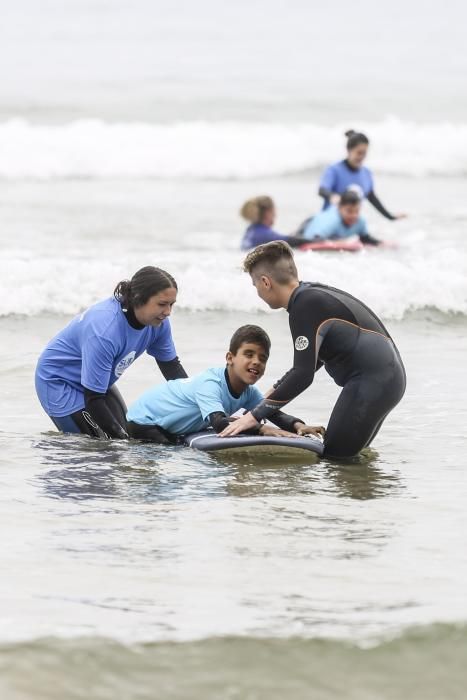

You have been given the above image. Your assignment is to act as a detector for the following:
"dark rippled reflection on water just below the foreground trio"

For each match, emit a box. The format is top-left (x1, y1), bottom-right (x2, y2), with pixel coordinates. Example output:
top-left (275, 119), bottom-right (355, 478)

top-left (33, 433), bottom-right (401, 503)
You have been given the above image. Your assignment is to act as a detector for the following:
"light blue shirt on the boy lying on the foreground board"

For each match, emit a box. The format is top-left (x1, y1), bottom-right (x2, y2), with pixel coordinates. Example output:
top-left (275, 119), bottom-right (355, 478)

top-left (127, 367), bottom-right (263, 435)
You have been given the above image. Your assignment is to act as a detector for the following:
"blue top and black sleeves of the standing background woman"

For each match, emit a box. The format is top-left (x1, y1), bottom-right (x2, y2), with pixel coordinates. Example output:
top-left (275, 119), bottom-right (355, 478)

top-left (318, 160), bottom-right (396, 221)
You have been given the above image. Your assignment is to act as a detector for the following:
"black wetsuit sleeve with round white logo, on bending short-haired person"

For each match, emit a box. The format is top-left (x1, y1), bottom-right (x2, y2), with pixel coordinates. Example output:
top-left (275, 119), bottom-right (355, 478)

top-left (252, 294), bottom-right (332, 420)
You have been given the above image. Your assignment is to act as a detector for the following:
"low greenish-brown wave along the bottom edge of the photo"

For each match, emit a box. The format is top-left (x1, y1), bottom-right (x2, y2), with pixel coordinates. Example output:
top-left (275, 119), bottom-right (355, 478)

top-left (0, 625), bottom-right (467, 700)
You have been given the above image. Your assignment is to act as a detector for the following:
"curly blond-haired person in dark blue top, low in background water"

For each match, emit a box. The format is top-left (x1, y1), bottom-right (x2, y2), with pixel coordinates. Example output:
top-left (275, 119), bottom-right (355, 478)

top-left (240, 196), bottom-right (303, 250)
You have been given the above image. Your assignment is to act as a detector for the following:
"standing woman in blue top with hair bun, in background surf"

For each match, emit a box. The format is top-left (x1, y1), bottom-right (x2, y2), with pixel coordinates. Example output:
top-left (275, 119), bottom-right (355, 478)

top-left (318, 129), bottom-right (407, 221)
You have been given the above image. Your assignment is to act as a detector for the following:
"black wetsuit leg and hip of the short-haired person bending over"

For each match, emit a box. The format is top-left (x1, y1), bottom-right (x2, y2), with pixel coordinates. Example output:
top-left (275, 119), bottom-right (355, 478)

top-left (324, 333), bottom-right (406, 459)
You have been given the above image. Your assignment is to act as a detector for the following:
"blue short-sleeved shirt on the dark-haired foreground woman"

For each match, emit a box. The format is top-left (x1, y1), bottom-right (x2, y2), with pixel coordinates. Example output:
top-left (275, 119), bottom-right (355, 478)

top-left (36, 297), bottom-right (176, 418)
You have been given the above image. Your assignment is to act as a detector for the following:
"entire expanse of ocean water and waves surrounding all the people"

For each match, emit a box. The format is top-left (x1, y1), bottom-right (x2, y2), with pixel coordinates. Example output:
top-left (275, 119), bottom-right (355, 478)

top-left (0, 0), bottom-right (467, 700)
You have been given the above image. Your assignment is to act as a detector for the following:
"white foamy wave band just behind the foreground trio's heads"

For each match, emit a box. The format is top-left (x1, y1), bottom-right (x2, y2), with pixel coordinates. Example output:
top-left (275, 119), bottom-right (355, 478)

top-left (0, 247), bottom-right (467, 319)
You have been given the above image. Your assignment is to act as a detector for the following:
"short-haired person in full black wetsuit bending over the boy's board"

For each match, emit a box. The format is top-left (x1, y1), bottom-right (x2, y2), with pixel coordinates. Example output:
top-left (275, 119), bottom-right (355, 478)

top-left (221, 241), bottom-right (406, 459)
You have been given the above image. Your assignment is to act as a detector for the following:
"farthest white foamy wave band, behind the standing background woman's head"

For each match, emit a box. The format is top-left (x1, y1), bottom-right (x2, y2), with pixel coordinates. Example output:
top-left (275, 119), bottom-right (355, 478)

top-left (0, 118), bottom-right (467, 179)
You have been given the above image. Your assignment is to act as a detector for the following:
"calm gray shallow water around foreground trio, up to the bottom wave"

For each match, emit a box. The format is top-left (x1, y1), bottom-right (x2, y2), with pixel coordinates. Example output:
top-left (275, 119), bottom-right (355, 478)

top-left (0, 313), bottom-right (467, 641)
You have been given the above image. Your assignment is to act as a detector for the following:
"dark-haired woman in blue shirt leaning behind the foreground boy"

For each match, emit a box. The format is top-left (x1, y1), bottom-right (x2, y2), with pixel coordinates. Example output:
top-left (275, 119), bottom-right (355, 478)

top-left (36, 266), bottom-right (187, 439)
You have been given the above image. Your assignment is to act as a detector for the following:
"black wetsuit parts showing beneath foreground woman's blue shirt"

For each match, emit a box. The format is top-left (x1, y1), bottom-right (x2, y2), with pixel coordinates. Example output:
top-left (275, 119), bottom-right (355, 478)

top-left (57, 309), bottom-right (188, 439)
